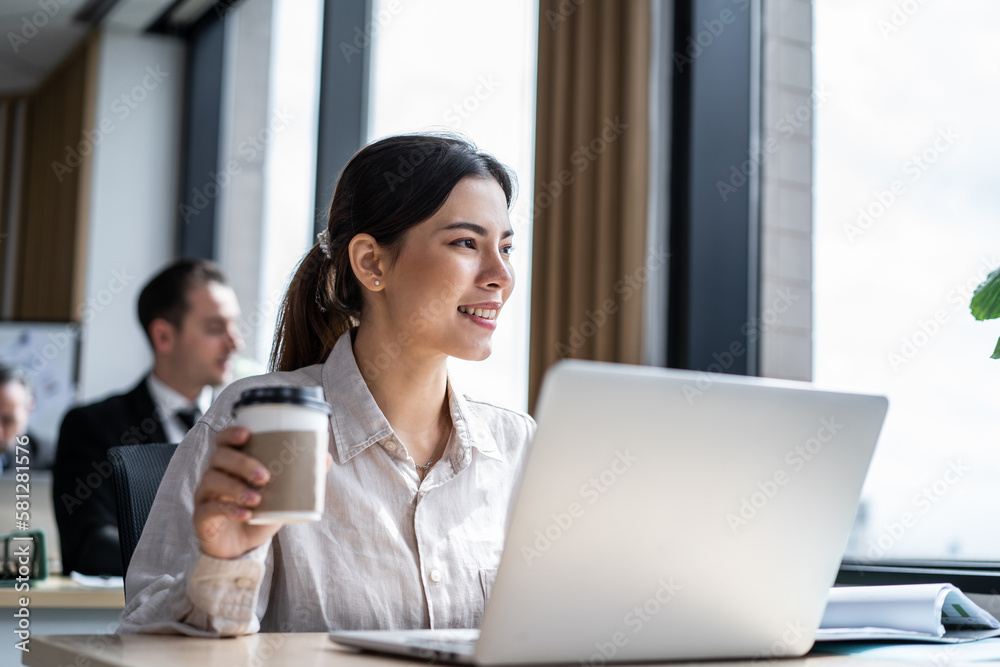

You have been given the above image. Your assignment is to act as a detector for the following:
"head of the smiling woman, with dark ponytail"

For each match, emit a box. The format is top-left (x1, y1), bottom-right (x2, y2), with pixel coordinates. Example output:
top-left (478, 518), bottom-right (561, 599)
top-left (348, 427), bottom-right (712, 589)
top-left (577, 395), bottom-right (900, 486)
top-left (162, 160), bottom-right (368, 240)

top-left (271, 134), bottom-right (514, 370)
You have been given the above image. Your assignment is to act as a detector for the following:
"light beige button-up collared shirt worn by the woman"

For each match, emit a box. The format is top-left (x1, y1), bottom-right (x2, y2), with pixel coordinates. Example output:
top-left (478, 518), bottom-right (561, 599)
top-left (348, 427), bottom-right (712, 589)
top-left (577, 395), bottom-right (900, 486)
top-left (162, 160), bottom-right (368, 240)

top-left (121, 333), bottom-right (535, 636)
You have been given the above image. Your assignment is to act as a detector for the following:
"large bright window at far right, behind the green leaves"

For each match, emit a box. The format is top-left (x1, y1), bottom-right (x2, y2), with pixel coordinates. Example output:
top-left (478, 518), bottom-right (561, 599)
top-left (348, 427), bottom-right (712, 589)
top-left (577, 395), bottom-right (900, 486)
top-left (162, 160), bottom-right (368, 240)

top-left (814, 0), bottom-right (1000, 561)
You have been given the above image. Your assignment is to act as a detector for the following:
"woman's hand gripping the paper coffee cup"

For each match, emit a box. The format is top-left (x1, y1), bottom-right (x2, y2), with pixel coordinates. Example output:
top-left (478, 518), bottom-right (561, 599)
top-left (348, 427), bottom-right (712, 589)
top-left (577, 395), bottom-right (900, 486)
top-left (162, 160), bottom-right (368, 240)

top-left (194, 426), bottom-right (282, 558)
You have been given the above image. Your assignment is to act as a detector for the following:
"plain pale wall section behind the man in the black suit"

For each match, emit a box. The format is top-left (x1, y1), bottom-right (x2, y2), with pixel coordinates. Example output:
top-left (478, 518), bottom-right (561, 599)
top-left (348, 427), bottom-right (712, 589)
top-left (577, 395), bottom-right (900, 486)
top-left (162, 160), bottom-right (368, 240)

top-left (78, 29), bottom-right (184, 401)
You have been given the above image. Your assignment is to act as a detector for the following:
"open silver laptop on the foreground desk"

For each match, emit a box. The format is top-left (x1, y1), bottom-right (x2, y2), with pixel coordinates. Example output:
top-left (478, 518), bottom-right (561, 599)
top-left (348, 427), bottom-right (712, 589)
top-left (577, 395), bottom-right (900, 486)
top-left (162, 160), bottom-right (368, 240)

top-left (330, 360), bottom-right (888, 665)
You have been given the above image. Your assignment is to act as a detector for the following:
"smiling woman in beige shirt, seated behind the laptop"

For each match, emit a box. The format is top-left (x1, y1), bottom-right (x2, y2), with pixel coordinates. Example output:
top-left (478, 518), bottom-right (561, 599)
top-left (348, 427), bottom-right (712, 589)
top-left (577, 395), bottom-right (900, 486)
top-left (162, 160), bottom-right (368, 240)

top-left (121, 135), bottom-right (535, 635)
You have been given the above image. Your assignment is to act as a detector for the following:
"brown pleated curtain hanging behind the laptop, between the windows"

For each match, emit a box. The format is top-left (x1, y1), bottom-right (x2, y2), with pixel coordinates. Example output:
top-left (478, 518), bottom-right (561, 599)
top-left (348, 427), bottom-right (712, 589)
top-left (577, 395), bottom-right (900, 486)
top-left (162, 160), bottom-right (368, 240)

top-left (529, 0), bottom-right (662, 410)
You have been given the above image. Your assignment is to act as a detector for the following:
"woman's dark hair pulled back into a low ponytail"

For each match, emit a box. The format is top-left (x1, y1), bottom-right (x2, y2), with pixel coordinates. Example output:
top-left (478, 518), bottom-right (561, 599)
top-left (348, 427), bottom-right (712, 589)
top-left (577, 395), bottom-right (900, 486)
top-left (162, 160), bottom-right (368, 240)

top-left (270, 134), bottom-right (515, 371)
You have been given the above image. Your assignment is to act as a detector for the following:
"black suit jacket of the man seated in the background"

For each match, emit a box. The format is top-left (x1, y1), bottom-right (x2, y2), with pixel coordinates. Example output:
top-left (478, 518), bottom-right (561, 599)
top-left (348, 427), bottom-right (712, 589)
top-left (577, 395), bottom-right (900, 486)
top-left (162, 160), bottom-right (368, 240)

top-left (52, 378), bottom-right (167, 575)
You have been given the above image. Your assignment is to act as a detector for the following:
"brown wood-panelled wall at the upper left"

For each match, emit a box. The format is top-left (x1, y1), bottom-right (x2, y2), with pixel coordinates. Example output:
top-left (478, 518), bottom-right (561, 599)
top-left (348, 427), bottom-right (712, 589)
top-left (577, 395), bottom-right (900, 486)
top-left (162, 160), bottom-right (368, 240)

top-left (0, 33), bottom-right (99, 321)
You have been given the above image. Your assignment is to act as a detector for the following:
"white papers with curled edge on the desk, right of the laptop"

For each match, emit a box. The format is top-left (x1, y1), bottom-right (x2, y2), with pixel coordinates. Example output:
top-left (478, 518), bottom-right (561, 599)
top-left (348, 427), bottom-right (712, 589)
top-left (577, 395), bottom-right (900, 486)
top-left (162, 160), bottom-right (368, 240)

top-left (816, 584), bottom-right (1000, 643)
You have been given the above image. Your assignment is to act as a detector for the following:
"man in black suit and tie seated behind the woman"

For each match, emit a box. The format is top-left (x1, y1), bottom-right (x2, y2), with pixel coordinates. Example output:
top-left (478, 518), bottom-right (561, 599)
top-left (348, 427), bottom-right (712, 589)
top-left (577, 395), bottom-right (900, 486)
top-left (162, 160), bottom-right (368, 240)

top-left (52, 259), bottom-right (242, 575)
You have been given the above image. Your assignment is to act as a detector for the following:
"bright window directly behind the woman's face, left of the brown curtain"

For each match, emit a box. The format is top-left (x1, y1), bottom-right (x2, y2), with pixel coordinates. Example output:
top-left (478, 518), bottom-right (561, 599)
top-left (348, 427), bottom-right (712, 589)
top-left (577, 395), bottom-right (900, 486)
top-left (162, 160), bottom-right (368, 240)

top-left (368, 0), bottom-right (538, 410)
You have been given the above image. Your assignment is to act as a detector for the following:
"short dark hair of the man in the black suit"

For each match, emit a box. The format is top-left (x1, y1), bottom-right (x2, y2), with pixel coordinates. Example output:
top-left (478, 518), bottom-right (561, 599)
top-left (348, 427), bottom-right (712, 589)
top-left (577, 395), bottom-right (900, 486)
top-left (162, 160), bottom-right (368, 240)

top-left (139, 259), bottom-right (228, 345)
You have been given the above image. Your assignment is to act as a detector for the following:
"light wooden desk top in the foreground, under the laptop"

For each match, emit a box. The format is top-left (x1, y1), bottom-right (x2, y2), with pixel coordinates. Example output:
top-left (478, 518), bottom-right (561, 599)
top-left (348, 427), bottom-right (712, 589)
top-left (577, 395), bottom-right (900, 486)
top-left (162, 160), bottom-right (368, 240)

top-left (22, 632), bottom-right (880, 667)
